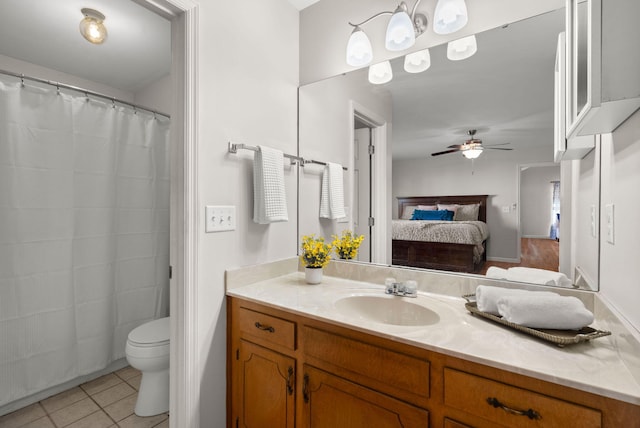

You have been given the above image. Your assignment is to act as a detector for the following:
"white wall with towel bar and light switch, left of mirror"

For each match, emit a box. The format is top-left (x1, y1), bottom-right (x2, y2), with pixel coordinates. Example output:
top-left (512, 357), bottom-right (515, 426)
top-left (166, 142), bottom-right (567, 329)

top-left (196, 0), bottom-right (299, 428)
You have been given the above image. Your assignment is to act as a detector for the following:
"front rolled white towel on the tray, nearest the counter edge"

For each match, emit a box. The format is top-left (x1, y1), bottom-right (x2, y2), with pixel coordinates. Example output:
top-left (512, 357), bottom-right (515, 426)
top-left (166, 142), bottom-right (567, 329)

top-left (498, 296), bottom-right (593, 330)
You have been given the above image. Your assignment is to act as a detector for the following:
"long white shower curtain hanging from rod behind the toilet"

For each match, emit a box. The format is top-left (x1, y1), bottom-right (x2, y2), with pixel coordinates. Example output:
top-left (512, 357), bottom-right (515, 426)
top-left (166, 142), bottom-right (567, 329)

top-left (0, 76), bottom-right (169, 406)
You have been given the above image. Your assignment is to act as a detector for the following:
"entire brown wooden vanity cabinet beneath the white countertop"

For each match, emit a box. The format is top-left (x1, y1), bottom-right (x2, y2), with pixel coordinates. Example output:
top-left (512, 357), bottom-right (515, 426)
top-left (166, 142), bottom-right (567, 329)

top-left (227, 297), bottom-right (640, 428)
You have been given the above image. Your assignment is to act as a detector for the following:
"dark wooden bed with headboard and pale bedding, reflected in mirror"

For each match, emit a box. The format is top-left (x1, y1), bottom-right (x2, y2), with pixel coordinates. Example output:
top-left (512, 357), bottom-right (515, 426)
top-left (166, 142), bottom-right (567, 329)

top-left (391, 195), bottom-right (489, 273)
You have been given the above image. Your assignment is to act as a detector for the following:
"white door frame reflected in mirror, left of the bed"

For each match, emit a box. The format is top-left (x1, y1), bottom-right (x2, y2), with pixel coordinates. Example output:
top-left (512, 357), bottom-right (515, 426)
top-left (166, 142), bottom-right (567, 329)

top-left (349, 100), bottom-right (391, 264)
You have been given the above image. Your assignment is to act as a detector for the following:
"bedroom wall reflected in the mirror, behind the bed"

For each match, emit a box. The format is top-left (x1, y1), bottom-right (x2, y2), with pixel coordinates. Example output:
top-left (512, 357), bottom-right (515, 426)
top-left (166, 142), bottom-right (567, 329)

top-left (393, 147), bottom-right (553, 261)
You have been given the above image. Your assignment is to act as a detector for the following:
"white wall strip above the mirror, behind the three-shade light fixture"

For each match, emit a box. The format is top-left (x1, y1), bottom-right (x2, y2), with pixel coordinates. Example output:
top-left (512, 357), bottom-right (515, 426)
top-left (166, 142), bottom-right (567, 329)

top-left (300, 0), bottom-right (565, 84)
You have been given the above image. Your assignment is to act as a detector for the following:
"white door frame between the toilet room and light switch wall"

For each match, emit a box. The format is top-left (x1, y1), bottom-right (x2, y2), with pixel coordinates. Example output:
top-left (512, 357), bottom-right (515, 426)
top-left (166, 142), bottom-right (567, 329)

top-left (139, 0), bottom-right (202, 428)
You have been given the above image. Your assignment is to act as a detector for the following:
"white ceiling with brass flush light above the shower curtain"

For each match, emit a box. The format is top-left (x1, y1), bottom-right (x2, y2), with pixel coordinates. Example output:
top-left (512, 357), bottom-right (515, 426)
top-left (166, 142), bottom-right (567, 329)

top-left (0, 0), bottom-right (171, 92)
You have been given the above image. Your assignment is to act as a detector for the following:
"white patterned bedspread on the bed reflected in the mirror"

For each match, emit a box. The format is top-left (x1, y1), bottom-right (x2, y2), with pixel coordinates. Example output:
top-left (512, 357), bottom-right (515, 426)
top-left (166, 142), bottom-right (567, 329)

top-left (391, 220), bottom-right (489, 262)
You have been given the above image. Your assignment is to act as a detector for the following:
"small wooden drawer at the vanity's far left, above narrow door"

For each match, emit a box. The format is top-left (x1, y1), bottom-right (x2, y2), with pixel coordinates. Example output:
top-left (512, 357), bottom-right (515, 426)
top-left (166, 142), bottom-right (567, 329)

top-left (238, 308), bottom-right (296, 350)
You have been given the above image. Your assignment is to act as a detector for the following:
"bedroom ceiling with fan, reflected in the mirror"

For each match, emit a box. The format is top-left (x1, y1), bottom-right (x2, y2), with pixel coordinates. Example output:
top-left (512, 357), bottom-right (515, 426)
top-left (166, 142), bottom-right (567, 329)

top-left (384, 9), bottom-right (564, 159)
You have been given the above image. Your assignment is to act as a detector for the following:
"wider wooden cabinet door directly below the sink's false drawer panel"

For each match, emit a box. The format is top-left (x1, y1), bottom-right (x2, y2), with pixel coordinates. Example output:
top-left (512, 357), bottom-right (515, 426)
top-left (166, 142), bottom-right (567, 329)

top-left (302, 366), bottom-right (429, 428)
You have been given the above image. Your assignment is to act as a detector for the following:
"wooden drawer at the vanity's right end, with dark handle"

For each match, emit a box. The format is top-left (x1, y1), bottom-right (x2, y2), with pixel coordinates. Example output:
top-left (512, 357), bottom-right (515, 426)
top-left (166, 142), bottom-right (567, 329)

top-left (444, 368), bottom-right (602, 428)
